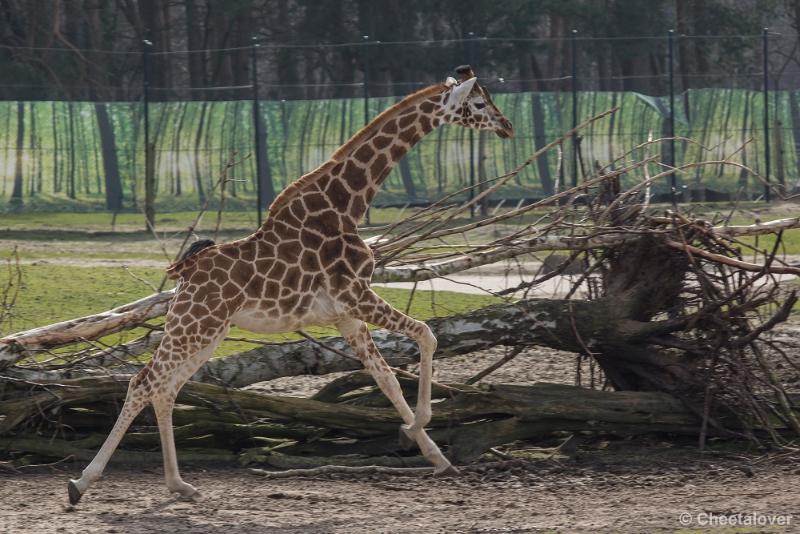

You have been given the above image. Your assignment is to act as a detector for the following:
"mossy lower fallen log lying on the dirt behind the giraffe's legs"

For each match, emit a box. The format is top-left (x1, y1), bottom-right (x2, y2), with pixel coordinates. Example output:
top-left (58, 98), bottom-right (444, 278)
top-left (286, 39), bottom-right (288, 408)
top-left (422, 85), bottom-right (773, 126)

top-left (0, 377), bottom-right (716, 468)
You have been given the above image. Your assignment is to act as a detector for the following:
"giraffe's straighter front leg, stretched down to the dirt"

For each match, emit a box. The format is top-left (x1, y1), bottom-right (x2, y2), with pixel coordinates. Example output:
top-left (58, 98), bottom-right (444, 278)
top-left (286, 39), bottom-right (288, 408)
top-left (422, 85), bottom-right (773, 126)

top-left (337, 319), bottom-right (458, 475)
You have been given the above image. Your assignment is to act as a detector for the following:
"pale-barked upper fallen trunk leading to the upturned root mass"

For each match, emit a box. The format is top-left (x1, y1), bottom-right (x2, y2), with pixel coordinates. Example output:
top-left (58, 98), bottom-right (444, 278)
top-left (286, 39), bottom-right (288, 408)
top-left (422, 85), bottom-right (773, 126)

top-left (6, 299), bottom-right (632, 387)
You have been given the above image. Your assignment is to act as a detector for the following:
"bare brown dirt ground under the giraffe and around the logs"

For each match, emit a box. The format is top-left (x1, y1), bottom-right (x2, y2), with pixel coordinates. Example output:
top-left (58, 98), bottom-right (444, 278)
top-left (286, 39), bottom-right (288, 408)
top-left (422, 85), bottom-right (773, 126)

top-left (0, 336), bottom-right (800, 534)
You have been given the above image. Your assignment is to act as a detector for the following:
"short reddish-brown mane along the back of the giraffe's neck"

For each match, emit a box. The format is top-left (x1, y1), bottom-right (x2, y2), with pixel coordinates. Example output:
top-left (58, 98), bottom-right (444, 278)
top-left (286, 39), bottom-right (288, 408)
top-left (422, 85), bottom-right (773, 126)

top-left (269, 83), bottom-right (448, 214)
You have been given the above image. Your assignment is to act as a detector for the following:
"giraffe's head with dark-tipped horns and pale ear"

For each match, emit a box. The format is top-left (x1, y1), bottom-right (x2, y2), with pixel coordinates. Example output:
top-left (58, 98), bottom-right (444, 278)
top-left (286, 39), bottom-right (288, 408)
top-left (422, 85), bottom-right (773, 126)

top-left (442, 65), bottom-right (514, 139)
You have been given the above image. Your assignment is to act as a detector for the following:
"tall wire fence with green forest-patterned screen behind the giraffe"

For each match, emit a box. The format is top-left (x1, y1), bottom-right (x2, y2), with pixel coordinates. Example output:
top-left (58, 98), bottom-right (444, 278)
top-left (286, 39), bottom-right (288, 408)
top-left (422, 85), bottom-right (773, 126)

top-left (0, 31), bottom-right (800, 215)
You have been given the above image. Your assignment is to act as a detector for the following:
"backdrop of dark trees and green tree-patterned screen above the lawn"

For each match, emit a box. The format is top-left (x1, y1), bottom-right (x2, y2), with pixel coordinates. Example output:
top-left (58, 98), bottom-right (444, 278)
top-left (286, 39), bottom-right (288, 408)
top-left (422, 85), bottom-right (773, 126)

top-left (0, 0), bottom-right (800, 211)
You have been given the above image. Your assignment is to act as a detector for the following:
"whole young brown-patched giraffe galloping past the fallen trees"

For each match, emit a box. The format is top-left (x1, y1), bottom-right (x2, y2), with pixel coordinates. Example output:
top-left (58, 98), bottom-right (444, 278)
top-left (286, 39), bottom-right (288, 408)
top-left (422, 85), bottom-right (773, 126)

top-left (68, 66), bottom-right (514, 505)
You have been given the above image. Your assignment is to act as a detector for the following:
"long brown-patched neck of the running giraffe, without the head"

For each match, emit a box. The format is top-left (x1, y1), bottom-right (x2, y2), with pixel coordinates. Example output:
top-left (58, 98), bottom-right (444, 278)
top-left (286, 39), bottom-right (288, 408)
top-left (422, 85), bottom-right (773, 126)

top-left (270, 86), bottom-right (443, 224)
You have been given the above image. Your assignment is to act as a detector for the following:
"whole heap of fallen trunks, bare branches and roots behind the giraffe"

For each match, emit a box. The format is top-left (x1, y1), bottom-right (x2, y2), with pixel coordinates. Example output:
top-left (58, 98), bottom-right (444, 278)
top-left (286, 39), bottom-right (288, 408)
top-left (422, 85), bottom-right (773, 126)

top-left (0, 110), bottom-right (800, 468)
